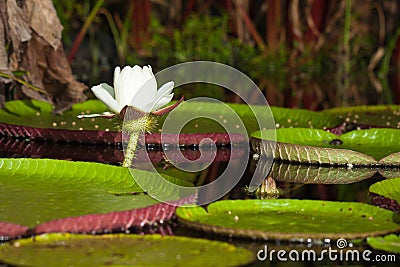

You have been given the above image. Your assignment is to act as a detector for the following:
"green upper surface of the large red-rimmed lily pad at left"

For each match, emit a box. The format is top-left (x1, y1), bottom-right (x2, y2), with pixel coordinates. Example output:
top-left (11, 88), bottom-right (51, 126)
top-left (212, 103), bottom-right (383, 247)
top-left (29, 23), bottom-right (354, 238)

top-left (0, 159), bottom-right (192, 227)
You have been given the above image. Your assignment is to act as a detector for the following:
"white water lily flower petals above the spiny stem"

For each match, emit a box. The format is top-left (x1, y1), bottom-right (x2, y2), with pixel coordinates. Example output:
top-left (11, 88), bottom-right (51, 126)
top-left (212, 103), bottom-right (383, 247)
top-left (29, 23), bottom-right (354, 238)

top-left (91, 65), bottom-right (174, 113)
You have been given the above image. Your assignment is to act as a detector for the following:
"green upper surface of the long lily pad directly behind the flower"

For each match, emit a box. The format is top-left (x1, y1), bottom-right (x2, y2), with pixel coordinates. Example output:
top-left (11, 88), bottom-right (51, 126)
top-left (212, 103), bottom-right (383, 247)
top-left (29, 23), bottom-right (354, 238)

top-left (0, 100), bottom-right (342, 133)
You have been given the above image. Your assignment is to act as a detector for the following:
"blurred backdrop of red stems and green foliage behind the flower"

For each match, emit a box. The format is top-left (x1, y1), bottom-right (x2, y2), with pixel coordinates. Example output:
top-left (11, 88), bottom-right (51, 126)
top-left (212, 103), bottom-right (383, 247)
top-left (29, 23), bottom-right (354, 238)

top-left (54, 0), bottom-right (400, 109)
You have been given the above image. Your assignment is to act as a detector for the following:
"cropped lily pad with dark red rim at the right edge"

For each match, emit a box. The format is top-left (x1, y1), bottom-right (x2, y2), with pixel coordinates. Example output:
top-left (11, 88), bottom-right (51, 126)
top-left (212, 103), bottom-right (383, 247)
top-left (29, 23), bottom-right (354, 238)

top-left (369, 178), bottom-right (400, 212)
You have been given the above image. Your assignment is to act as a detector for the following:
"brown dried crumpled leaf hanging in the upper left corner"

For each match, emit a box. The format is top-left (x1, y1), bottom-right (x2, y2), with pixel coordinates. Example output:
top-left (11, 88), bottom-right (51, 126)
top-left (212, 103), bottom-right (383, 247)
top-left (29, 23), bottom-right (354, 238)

top-left (0, 0), bottom-right (87, 113)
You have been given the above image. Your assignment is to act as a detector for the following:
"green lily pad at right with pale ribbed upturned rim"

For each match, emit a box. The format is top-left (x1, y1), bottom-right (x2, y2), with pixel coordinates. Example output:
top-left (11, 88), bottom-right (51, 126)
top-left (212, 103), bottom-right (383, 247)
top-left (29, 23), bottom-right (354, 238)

top-left (251, 128), bottom-right (400, 165)
